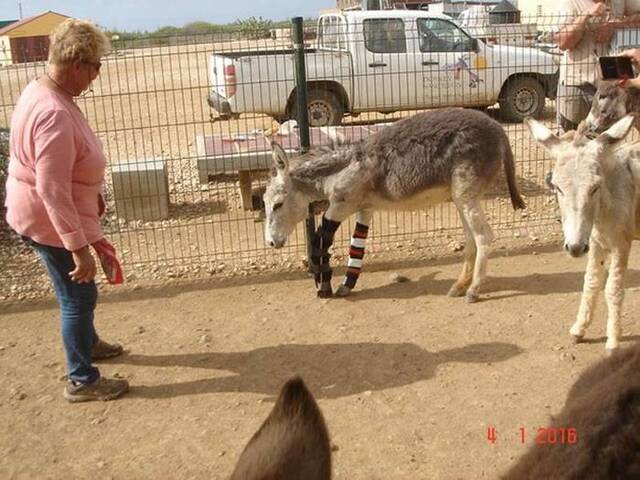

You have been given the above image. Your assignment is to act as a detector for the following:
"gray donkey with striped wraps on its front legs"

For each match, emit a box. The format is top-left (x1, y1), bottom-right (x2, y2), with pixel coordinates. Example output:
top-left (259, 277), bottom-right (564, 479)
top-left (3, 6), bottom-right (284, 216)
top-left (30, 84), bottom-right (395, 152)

top-left (264, 109), bottom-right (525, 302)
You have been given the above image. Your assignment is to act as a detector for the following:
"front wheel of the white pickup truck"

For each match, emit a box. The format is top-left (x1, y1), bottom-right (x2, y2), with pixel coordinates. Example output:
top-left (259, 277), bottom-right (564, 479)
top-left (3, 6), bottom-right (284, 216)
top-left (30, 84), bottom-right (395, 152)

top-left (498, 77), bottom-right (545, 122)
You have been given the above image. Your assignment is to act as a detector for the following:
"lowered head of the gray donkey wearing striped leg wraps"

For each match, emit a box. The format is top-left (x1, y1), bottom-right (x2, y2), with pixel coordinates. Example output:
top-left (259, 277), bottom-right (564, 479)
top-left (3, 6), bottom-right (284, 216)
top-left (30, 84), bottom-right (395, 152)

top-left (264, 142), bottom-right (309, 248)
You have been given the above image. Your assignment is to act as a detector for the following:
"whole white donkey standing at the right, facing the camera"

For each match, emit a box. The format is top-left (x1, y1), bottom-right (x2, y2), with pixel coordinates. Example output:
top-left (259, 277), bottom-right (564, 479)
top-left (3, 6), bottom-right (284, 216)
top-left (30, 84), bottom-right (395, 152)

top-left (527, 115), bottom-right (640, 352)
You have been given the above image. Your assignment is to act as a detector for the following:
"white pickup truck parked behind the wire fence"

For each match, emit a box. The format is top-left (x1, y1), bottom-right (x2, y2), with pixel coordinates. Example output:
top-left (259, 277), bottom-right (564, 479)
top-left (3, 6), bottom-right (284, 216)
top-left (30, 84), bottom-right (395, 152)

top-left (207, 10), bottom-right (558, 126)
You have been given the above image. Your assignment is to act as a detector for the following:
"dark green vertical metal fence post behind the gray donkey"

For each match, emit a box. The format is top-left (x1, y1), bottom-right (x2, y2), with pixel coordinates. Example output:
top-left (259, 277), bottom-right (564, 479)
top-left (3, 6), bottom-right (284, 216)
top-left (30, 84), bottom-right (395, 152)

top-left (291, 17), bottom-right (316, 268)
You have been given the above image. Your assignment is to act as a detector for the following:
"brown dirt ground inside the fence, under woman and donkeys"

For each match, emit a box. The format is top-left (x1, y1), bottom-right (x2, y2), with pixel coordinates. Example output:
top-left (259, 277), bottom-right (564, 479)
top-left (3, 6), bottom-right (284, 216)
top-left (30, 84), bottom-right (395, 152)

top-left (0, 245), bottom-right (640, 480)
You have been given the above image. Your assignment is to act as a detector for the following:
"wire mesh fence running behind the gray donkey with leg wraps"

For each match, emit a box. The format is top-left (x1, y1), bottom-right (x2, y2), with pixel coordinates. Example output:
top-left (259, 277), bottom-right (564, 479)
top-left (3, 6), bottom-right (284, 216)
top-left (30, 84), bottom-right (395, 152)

top-left (0, 10), bottom-right (636, 294)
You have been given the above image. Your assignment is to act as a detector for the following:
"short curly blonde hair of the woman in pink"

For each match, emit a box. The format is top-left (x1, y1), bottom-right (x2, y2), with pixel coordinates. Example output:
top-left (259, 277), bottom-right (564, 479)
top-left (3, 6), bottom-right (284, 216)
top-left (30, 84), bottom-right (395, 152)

top-left (49, 18), bottom-right (110, 66)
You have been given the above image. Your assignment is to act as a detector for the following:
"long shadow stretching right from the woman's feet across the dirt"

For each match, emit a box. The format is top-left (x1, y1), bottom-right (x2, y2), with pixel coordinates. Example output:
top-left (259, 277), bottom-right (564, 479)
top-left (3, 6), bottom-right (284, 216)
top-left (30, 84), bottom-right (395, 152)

top-left (109, 342), bottom-right (522, 400)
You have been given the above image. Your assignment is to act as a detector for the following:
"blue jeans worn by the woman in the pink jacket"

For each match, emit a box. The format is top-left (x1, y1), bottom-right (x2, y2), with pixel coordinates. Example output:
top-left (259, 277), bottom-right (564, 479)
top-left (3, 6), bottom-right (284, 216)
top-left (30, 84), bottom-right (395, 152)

top-left (24, 238), bottom-right (100, 383)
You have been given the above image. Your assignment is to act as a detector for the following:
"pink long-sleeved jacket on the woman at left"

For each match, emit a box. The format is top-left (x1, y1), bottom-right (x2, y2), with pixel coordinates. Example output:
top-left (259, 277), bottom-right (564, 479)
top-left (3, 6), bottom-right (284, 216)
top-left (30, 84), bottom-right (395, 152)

top-left (5, 80), bottom-right (105, 251)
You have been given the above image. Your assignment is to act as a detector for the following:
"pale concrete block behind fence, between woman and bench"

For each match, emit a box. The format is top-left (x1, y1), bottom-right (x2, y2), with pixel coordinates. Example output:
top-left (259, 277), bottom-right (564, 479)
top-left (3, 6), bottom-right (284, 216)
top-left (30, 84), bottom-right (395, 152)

top-left (111, 158), bottom-right (169, 220)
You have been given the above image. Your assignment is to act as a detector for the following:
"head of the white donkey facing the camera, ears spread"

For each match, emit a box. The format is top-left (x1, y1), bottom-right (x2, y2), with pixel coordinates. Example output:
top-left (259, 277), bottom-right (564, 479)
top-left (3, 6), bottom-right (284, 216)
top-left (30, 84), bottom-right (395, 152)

top-left (526, 115), bottom-right (634, 257)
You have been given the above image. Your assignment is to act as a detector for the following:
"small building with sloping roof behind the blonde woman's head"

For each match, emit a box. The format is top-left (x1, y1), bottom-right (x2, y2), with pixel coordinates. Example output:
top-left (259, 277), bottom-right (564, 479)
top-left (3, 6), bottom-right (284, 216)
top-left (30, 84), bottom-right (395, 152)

top-left (0, 11), bottom-right (69, 66)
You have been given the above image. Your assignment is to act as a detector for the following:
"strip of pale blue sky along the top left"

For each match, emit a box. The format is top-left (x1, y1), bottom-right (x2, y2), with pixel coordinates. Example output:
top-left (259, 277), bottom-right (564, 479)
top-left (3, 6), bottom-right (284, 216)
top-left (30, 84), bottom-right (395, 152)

top-left (6, 0), bottom-right (336, 31)
